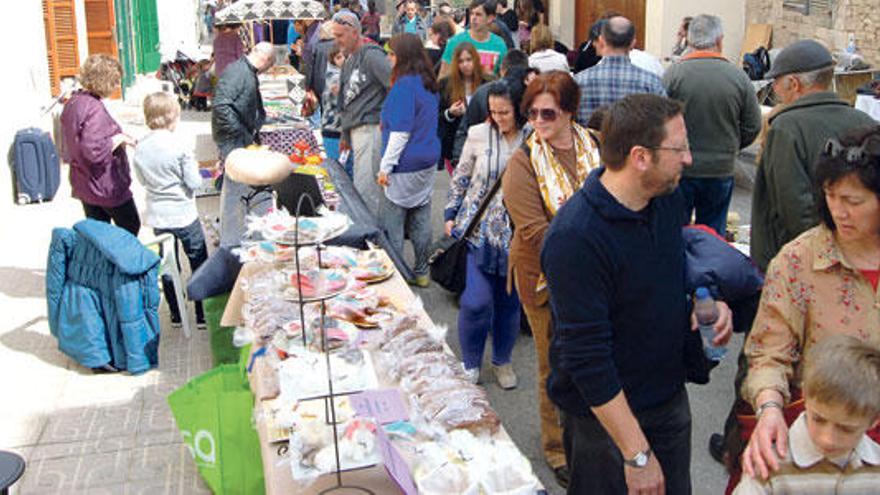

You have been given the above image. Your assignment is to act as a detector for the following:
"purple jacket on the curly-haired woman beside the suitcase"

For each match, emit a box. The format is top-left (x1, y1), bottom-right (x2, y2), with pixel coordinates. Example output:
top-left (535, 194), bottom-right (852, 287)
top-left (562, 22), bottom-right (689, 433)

top-left (61, 91), bottom-right (131, 208)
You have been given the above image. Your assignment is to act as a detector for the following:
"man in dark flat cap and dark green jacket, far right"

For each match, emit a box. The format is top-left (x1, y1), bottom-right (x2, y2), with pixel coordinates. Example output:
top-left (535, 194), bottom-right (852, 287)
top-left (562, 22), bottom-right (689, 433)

top-left (751, 40), bottom-right (875, 270)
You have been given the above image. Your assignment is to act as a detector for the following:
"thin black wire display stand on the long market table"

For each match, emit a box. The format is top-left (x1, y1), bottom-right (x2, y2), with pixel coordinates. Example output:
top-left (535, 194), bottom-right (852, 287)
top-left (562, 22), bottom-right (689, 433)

top-left (293, 194), bottom-right (375, 495)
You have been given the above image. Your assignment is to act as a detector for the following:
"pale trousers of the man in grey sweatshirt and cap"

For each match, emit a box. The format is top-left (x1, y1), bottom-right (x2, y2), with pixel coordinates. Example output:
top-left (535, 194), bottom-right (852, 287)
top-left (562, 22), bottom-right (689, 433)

top-left (349, 124), bottom-right (385, 215)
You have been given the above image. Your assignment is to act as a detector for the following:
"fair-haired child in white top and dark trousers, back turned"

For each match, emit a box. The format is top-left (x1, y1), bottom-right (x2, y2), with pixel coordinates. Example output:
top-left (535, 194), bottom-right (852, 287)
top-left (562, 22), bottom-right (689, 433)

top-left (134, 92), bottom-right (208, 325)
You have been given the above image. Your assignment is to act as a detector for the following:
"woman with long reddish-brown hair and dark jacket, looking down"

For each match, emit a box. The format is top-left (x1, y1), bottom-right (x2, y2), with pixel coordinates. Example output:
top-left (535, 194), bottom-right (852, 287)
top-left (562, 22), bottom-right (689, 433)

top-left (439, 42), bottom-right (492, 175)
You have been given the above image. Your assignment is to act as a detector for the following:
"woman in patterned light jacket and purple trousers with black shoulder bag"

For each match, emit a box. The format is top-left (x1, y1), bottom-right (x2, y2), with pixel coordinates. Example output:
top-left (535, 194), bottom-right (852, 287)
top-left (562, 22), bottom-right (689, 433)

top-left (444, 81), bottom-right (526, 390)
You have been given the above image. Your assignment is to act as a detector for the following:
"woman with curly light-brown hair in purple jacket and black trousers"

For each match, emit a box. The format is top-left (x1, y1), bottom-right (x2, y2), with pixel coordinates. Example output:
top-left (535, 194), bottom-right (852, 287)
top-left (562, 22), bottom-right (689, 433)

top-left (61, 55), bottom-right (141, 235)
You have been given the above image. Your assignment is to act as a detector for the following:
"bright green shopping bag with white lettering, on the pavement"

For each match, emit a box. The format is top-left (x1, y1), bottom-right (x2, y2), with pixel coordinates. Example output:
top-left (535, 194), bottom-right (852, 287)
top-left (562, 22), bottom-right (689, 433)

top-left (168, 364), bottom-right (265, 495)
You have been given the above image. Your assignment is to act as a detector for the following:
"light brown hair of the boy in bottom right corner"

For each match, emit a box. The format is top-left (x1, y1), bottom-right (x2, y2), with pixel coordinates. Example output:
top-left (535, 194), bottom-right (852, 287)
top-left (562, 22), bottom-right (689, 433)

top-left (803, 335), bottom-right (880, 421)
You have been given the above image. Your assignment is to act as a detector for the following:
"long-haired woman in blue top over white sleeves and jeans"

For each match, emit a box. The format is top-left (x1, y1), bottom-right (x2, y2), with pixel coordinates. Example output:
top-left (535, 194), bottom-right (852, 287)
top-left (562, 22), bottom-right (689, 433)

top-left (376, 33), bottom-right (440, 287)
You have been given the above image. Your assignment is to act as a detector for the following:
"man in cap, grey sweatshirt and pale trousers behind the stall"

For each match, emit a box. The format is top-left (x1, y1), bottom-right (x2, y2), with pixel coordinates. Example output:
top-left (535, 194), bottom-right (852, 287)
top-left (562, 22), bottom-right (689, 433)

top-left (333, 10), bottom-right (391, 215)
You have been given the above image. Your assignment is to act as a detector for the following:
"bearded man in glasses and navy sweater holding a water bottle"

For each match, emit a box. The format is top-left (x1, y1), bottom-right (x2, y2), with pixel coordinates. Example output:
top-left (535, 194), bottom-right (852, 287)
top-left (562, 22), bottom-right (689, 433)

top-left (541, 94), bottom-right (732, 495)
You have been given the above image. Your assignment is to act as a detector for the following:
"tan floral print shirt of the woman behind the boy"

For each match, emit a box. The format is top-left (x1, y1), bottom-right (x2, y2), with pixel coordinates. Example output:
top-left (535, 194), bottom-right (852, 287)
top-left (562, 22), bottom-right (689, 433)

top-left (742, 225), bottom-right (880, 406)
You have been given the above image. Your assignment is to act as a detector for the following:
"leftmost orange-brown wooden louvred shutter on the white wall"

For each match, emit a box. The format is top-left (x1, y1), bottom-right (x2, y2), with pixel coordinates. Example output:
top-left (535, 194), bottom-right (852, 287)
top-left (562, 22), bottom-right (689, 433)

top-left (43, 0), bottom-right (79, 96)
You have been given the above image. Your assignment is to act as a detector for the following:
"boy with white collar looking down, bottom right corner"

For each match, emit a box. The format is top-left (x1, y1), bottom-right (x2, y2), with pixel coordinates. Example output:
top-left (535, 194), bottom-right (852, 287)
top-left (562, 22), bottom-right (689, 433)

top-left (733, 335), bottom-right (880, 495)
